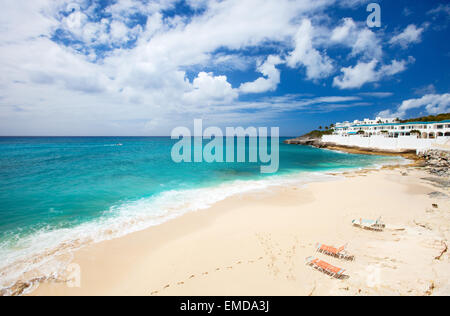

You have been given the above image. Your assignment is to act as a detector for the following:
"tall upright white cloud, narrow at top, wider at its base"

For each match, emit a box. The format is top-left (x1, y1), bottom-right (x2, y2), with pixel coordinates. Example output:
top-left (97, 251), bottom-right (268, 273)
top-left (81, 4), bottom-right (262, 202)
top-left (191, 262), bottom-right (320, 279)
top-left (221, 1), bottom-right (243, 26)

top-left (286, 19), bottom-right (334, 80)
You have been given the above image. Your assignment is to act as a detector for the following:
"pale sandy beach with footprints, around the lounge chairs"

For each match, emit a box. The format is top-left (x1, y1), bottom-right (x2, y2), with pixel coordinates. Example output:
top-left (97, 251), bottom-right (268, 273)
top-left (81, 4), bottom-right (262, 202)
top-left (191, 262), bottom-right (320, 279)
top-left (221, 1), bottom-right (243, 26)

top-left (32, 166), bottom-right (450, 296)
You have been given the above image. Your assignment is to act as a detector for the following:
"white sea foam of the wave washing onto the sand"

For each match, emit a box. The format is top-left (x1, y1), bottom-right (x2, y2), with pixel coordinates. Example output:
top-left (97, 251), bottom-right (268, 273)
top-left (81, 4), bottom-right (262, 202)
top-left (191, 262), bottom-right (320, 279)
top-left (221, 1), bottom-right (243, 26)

top-left (0, 159), bottom-right (401, 295)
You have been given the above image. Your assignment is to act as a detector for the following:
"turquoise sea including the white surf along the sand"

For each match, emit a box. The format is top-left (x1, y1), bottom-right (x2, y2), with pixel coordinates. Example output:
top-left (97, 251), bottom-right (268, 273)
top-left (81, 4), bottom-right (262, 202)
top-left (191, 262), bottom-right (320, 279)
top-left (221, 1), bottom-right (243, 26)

top-left (0, 137), bottom-right (399, 289)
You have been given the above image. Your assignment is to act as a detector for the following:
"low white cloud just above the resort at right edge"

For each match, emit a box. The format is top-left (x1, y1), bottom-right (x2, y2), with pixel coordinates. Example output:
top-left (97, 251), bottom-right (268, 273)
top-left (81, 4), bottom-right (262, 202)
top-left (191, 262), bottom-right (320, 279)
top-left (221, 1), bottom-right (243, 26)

top-left (379, 93), bottom-right (450, 118)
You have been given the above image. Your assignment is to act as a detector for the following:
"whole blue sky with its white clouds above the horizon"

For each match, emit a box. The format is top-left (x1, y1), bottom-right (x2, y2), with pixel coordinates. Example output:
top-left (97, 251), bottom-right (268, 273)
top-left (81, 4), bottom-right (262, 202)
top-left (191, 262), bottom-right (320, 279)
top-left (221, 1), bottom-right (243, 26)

top-left (0, 0), bottom-right (450, 136)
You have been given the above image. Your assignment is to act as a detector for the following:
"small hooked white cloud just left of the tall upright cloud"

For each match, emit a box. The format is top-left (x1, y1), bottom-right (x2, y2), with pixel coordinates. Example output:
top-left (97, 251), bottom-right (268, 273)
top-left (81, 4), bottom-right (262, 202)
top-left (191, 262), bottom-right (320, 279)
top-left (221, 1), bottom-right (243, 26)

top-left (239, 55), bottom-right (283, 93)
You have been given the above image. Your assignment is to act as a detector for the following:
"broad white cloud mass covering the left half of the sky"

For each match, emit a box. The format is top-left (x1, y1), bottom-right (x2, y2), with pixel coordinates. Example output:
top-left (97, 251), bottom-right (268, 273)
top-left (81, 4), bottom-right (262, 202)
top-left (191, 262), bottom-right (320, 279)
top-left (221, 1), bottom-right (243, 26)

top-left (0, 0), bottom-right (332, 131)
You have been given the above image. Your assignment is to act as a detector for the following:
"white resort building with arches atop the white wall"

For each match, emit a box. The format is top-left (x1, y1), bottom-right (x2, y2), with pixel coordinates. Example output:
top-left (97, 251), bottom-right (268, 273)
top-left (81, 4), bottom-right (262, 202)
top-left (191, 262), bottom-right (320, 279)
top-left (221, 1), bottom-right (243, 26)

top-left (333, 117), bottom-right (450, 139)
